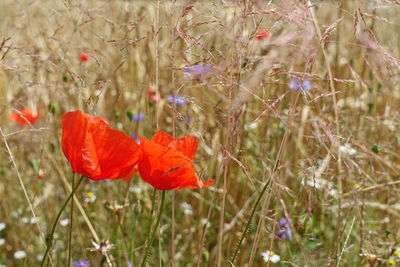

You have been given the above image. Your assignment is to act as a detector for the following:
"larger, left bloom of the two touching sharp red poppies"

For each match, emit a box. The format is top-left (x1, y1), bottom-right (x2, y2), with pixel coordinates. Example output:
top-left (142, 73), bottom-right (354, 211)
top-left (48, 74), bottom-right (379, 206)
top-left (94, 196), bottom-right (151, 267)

top-left (61, 110), bottom-right (141, 180)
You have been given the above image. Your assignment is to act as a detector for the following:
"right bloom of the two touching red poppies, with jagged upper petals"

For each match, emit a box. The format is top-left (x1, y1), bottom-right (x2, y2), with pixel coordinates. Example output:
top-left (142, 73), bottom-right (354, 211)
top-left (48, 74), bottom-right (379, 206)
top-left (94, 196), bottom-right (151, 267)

top-left (138, 130), bottom-right (214, 190)
